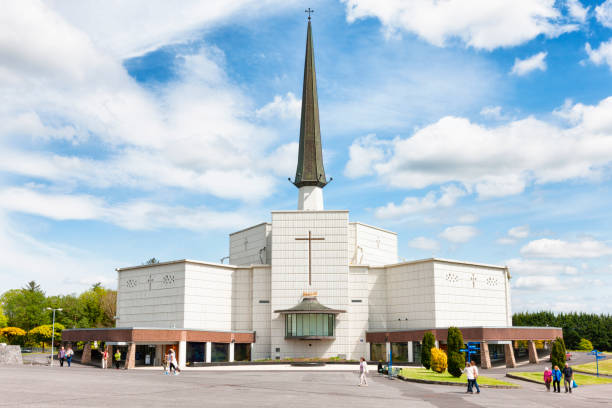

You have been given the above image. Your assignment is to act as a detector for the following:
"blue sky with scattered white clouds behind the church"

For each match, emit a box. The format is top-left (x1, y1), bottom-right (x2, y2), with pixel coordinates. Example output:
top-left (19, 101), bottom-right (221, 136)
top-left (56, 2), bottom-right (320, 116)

top-left (0, 0), bottom-right (612, 313)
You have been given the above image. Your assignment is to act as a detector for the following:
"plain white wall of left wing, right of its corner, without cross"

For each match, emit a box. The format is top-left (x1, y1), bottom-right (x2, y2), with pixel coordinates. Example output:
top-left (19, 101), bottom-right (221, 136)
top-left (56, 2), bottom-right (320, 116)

top-left (183, 262), bottom-right (236, 330)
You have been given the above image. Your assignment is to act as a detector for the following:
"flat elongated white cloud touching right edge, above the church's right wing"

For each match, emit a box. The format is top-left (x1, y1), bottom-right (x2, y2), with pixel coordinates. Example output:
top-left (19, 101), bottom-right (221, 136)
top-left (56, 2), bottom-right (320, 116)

top-left (521, 238), bottom-right (612, 259)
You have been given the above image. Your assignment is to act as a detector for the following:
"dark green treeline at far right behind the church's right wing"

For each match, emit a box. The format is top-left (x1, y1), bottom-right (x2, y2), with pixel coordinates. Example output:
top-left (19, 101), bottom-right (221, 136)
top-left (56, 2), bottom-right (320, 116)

top-left (512, 312), bottom-right (612, 351)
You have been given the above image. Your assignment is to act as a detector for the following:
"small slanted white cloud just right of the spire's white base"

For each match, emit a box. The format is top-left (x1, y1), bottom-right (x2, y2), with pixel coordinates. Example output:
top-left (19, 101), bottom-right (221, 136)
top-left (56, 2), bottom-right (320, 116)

top-left (375, 184), bottom-right (467, 219)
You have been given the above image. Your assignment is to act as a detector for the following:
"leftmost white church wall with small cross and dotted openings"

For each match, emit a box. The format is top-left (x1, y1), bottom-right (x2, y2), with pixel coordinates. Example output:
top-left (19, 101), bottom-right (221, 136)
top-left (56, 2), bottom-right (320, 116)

top-left (117, 262), bottom-right (185, 327)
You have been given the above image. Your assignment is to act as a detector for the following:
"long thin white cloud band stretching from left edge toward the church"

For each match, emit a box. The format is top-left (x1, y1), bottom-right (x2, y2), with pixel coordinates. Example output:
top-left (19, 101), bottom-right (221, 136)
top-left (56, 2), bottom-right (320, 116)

top-left (0, 188), bottom-right (252, 231)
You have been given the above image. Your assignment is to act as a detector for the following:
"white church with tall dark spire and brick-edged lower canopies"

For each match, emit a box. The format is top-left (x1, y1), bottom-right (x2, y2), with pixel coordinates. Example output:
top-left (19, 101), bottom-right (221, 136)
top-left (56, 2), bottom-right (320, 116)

top-left (63, 20), bottom-right (562, 368)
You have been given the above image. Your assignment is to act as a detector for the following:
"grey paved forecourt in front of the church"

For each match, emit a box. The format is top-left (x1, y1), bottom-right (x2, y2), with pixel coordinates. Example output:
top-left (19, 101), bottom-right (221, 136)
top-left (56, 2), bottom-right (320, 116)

top-left (0, 365), bottom-right (612, 408)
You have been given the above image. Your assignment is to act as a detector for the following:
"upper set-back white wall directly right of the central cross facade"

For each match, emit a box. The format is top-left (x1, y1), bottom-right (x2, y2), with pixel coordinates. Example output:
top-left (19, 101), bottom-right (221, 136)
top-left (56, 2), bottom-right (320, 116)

top-left (348, 222), bottom-right (398, 265)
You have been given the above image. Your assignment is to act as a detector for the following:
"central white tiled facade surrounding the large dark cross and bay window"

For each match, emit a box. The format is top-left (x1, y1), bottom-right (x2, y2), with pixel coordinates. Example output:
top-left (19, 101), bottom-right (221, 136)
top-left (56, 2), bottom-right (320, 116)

top-left (271, 211), bottom-right (354, 358)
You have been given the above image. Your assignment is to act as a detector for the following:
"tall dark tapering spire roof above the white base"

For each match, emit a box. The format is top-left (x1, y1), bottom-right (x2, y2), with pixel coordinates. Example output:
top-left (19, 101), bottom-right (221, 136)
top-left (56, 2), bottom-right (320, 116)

top-left (293, 20), bottom-right (331, 188)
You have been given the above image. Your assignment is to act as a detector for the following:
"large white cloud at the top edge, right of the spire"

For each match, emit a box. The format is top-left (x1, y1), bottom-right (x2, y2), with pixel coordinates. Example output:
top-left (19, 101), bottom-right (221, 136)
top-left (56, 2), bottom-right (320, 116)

top-left (343, 0), bottom-right (577, 50)
